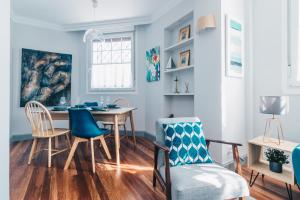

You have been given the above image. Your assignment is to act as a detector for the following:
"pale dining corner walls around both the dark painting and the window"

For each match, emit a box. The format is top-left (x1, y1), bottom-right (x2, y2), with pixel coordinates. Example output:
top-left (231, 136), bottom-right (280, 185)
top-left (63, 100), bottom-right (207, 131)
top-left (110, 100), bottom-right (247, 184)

top-left (10, 23), bottom-right (146, 135)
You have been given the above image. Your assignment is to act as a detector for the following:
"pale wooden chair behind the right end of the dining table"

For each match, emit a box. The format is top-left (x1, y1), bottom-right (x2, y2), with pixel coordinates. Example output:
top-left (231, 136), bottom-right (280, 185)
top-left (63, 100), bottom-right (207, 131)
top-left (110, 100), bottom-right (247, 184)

top-left (102, 98), bottom-right (136, 145)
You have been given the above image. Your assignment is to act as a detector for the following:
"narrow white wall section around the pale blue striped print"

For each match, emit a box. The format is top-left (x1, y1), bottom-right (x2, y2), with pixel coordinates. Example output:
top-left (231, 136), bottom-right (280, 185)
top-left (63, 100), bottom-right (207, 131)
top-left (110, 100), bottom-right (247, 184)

top-left (221, 0), bottom-right (249, 162)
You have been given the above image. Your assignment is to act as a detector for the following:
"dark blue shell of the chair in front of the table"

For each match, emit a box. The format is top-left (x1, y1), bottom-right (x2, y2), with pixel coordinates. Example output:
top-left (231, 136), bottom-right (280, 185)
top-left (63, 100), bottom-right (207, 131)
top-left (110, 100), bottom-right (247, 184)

top-left (69, 108), bottom-right (102, 138)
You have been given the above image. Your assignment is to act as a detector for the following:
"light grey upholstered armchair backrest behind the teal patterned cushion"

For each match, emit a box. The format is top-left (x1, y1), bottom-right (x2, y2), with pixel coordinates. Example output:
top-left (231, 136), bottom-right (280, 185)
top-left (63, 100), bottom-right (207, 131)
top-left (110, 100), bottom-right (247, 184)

top-left (155, 117), bottom-right (200, 167)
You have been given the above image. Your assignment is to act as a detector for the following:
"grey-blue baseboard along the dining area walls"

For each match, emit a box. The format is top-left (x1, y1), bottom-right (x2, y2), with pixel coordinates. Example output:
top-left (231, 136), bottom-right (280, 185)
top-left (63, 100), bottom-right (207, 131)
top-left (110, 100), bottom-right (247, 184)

top-left (9, 131), bottom-right (155, 143)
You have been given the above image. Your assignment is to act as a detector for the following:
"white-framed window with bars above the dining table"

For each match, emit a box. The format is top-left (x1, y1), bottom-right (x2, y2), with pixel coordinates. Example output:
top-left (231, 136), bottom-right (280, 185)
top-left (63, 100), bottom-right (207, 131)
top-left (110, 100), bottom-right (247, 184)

top-left (89, 32), bottom-right (134, 92)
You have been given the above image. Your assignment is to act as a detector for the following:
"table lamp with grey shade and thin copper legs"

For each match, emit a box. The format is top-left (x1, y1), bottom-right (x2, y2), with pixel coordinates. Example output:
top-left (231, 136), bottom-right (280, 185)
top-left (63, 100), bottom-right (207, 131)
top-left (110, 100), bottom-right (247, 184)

top-left (259, 96), bottom-right (289, 144)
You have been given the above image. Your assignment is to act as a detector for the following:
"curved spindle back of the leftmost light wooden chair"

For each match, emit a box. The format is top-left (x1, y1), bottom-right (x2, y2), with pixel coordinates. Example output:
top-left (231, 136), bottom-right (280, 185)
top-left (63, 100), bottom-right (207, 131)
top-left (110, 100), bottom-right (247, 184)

top-left (25, 101), bottom-right (54, 137)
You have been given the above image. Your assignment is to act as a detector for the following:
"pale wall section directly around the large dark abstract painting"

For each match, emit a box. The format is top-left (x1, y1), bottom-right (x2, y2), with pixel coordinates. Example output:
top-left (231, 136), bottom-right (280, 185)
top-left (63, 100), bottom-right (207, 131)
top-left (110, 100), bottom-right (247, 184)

top-left (10, 23), bottom-right (81, 135)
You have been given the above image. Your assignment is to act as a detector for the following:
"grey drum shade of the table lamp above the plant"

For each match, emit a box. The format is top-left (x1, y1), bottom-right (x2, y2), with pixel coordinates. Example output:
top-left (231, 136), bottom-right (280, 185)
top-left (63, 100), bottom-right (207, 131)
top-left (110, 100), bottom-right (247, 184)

top-left (259, 96), bottom-right (289, 115)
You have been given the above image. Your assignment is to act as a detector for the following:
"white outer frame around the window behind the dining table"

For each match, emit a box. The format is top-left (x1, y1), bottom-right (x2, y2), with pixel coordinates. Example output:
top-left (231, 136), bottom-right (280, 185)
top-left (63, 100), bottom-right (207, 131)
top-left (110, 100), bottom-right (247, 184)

top-left (86, 31), bottom-right (136, 94)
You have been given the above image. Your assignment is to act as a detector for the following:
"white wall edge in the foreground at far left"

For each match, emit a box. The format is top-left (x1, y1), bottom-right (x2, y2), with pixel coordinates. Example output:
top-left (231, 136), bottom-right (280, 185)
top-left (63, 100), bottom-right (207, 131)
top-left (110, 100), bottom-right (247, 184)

top-left (0, 0), bottom-right (10, 199)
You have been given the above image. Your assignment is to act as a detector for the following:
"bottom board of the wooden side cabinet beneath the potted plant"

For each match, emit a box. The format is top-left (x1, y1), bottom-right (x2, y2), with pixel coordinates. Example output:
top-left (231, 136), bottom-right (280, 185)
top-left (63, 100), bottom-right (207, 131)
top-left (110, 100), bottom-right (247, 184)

top-left (249, 162), bottom-right (294, 184)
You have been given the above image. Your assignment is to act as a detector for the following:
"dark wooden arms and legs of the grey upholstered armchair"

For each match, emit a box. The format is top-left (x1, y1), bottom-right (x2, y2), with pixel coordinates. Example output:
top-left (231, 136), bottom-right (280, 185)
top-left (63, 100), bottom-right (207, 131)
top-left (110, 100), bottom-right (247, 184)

top-left (153, 139), bottom-right (245, 200)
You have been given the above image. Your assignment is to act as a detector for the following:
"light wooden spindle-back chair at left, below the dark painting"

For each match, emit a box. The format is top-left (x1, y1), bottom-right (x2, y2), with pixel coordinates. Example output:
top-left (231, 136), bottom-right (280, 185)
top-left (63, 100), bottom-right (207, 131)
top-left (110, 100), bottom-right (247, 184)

top-left (25, 101), bottom-right (71, 167)
